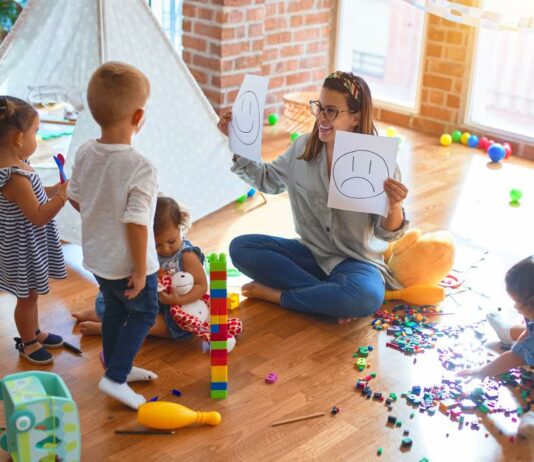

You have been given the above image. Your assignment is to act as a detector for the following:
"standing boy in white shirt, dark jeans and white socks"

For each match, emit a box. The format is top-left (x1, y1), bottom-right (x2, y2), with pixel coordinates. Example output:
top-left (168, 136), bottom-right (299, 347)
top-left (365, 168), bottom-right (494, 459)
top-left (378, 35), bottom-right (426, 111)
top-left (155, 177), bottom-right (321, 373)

top-left (68, 62), bottom-right (158, 409)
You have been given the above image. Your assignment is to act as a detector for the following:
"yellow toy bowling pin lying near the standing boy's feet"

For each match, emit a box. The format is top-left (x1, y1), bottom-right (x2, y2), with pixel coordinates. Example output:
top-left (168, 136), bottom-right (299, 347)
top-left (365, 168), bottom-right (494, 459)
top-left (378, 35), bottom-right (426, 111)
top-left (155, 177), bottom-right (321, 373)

top-left (137, 401), bottom-right (222, 430)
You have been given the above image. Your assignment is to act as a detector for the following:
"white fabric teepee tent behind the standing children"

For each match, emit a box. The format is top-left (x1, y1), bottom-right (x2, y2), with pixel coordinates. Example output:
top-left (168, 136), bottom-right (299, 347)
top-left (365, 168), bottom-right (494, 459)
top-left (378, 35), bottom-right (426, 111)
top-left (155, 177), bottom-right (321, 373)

top-left (0, 0), bottom-right (248, 243)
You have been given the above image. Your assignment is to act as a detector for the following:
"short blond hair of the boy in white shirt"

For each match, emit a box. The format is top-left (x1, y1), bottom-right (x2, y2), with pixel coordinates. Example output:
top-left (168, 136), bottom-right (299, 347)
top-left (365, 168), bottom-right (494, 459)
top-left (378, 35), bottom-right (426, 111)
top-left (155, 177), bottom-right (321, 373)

top-left (87, 61), bottom-right (150, 127)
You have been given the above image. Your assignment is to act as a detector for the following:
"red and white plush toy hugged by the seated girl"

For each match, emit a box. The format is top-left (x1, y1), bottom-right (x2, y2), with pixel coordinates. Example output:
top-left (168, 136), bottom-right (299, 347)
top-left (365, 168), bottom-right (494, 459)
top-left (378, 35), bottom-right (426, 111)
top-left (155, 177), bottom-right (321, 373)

top-left (159, 271), bottom-right (243, 352)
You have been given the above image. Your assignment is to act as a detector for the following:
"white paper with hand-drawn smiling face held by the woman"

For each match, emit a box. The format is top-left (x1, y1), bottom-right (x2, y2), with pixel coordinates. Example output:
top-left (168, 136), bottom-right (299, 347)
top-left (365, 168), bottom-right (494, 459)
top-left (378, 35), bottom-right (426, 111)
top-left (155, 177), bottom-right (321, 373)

top-left (228, 75), bottom-right (269, 162)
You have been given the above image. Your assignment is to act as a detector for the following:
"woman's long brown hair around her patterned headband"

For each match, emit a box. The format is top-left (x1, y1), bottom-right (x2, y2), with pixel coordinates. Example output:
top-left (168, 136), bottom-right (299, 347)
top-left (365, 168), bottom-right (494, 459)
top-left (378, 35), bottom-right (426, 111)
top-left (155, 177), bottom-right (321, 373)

top-left (299, 71), bottom-right (378, 161)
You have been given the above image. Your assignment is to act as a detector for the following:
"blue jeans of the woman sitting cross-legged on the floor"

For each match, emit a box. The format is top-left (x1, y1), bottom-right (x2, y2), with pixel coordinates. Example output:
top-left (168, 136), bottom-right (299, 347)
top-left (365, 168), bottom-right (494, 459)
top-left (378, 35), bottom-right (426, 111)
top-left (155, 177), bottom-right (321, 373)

top-left (230, 234), bottom-right (385, 318)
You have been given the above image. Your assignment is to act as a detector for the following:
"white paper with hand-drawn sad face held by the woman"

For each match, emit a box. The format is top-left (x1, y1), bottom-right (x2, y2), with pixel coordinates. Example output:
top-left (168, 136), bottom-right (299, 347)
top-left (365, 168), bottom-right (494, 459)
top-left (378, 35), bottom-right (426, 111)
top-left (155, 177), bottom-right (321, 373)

top-left (327, 131), bottom-right (399, 217)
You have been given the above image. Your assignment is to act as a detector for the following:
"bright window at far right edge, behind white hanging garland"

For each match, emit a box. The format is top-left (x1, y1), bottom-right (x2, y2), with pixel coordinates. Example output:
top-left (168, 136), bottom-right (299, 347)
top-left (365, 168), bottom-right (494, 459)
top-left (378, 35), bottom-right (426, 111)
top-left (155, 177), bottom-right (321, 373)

top-left (467, 0), bottom-right (534, 139)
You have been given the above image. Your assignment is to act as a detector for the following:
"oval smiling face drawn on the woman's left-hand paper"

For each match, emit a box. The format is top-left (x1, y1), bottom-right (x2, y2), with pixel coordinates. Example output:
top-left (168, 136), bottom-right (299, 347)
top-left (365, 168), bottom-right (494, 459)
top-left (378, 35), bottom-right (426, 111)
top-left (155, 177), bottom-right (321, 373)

top-left (231, 91), bottom-right (261, 145)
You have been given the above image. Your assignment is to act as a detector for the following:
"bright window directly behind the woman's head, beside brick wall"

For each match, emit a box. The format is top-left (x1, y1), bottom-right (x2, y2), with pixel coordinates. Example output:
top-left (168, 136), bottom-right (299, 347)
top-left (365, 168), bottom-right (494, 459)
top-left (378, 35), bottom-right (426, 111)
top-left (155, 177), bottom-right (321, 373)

top-left (336, 0), bottom-right (425, 110)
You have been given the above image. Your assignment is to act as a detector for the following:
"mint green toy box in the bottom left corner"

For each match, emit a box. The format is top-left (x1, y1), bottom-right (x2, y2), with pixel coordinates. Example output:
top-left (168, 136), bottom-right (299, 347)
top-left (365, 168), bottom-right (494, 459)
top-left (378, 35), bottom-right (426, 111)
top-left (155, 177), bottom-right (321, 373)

top-left (0, 371), bottom-right (81, 462)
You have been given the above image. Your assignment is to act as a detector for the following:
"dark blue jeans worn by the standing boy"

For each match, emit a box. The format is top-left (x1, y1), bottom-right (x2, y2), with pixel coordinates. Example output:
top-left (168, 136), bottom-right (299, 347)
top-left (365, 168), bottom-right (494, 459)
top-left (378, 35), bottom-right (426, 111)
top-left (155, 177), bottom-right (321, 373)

top-left (95, 273), bottom-right (158, 383)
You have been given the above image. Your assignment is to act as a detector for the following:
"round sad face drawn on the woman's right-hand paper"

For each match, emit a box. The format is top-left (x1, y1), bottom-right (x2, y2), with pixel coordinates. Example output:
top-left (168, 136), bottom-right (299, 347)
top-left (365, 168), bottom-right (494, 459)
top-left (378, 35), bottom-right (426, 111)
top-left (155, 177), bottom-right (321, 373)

top-left (332, 149), bottom-right (389, 199)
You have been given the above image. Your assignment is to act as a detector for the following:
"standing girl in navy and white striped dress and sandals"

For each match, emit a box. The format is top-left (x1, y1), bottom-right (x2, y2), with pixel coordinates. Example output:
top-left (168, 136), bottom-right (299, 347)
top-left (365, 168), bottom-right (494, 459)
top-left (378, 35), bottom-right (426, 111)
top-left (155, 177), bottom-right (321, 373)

top-left (0, 96), bottom-right (67, 364)
